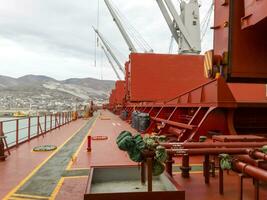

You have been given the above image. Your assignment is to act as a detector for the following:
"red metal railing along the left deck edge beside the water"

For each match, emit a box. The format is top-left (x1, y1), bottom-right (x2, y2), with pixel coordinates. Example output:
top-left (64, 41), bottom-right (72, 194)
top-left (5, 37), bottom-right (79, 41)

top-left (0, 112), bottom-right (72, 149)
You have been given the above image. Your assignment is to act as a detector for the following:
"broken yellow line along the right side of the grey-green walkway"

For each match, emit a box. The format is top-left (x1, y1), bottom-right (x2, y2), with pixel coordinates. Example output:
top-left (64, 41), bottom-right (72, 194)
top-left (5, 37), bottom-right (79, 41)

top-left (49, 115), bottom-right (99, 200)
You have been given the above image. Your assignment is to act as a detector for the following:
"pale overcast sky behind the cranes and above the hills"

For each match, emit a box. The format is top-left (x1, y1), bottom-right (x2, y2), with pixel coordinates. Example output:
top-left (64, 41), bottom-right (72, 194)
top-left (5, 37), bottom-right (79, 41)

top-left (0, 0), bottom-right (212, 80)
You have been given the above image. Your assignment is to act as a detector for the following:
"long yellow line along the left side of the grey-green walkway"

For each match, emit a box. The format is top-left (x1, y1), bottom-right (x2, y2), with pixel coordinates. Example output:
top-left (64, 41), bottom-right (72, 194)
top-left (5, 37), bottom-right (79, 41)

top-left (3, 119), bottom-right (89, 200)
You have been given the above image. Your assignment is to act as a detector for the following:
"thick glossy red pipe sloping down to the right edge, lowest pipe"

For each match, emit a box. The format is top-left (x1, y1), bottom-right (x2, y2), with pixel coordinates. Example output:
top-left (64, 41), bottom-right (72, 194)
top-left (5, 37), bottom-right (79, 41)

top-left (232, 159), bottom-right (267, 182)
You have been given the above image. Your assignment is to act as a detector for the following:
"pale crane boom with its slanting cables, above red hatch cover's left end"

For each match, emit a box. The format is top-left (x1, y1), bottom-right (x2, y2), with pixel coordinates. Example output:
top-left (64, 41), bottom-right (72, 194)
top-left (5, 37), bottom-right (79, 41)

top-left (104, 0), bottom-right (153, 53)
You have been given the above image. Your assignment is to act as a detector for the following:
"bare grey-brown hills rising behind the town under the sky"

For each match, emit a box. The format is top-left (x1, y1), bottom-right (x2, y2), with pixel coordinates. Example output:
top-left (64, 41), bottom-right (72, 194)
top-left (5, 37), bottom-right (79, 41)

top-left (0, 75), bottom-right (115, 100)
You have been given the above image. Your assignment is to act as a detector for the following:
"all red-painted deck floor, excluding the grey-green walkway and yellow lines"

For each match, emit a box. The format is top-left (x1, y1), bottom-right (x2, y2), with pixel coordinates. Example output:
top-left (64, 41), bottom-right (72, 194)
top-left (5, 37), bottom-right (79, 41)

top-left (0, 111), bottom-right (267, 200)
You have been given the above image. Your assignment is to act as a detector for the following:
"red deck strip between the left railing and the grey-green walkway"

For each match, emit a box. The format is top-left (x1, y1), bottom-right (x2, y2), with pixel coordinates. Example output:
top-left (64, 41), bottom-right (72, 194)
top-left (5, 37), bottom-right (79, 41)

top-left (0, 120), bottom-right (86, 199)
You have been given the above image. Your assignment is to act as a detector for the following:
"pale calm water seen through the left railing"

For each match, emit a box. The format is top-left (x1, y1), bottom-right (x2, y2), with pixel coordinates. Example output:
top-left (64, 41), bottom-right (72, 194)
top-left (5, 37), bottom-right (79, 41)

top-left (0, 116), bottom-right (55, 146)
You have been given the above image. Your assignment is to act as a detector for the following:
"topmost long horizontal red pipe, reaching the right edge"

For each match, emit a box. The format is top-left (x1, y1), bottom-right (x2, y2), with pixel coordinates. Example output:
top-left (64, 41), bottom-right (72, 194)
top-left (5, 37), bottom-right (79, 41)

top-left (160, 142), bottom-right (267, 149)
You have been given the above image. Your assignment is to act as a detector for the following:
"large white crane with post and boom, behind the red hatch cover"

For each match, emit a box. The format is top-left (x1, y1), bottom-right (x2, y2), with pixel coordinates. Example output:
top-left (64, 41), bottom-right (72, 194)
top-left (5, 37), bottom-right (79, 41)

top-left (157, 0), bottom-right (201, 54)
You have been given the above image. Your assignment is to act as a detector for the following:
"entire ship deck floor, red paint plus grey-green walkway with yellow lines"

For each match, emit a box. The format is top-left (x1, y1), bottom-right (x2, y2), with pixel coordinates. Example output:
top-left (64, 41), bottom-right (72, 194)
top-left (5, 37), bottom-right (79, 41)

top-left (0, 110), bottom-right (267, 200)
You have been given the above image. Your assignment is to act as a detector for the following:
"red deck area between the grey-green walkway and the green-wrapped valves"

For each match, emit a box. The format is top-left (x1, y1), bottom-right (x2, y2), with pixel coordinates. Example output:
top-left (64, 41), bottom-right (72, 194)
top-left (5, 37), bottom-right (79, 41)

top-left (56, 111), bottom-right (136, 200)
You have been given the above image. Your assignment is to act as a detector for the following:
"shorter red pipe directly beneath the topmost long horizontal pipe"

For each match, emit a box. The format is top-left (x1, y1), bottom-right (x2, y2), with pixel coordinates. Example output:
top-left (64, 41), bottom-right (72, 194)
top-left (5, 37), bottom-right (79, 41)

top-left (167, 148), bottom-right (247, 156)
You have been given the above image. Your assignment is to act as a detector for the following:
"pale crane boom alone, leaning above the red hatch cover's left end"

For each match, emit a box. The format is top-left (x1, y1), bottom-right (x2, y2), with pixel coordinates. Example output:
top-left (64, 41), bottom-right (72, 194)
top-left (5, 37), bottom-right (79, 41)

top-left (104, 0), bottom-right (137, 53)
